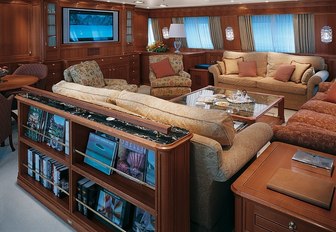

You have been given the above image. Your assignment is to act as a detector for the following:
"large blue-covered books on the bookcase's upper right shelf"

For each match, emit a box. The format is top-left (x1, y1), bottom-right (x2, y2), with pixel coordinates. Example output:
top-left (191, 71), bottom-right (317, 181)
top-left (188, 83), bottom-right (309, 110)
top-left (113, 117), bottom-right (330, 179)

top-left (84, 132), bottom-right (155, 186)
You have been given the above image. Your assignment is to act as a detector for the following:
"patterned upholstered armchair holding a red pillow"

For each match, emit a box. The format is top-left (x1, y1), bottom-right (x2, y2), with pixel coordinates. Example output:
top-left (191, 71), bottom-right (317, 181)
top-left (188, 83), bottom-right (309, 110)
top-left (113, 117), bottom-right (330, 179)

top-left (149, 54), bottom-right (191, 99)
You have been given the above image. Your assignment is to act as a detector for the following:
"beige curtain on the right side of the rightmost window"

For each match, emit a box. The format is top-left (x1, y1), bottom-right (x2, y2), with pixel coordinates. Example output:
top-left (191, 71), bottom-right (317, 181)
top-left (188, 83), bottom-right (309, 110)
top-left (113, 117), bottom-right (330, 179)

top-left (293, 14), bottom-right (315, 53)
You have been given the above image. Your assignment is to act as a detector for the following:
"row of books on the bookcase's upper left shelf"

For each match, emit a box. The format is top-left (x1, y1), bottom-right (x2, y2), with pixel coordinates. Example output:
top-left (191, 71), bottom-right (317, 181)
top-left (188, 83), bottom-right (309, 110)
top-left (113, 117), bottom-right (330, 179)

top-left (25, 106), bottom-right (69, 155)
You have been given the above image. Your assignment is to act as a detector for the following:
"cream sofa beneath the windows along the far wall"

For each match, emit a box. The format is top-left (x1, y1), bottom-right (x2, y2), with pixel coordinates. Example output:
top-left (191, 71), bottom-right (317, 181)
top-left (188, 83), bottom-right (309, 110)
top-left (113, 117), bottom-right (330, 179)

top-left (209, 51), bottom-right (329, 109)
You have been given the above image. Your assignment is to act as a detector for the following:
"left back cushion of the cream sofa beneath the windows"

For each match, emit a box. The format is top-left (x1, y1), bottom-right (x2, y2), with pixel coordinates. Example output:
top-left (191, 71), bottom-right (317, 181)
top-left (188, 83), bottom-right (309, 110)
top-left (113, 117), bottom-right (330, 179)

top-left (223, 51), bottom-right (267, 77)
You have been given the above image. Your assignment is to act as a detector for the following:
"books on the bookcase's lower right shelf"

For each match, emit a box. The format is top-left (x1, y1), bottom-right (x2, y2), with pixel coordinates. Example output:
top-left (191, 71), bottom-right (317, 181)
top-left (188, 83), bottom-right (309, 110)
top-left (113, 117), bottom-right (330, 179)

top-left (77, 178), bottom-right (155, 232)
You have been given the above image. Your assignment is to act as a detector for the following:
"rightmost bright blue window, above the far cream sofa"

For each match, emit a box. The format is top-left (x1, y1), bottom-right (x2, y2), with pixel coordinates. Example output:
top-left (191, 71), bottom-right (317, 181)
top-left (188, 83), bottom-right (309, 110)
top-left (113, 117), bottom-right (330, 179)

top-left (252, 14), bottom-right (295, 52)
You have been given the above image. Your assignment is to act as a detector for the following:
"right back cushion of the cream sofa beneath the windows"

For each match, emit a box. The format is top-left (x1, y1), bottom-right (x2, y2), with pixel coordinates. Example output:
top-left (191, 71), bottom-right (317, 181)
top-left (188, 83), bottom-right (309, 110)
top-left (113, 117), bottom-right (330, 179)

top-left (267, 52), bottom-right (326, 77)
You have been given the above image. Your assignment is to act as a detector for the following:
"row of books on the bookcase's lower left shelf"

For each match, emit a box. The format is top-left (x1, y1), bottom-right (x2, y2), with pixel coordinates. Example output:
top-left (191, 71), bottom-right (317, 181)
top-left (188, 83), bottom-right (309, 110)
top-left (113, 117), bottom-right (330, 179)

top-left (27, 148), bottom-right (69, 198)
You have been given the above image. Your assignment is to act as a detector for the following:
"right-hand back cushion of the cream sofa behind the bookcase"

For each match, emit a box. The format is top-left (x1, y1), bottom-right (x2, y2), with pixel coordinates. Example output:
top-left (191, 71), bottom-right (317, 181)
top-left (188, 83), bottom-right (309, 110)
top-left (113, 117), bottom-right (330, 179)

top-left (116, 91), bottom-right (235, 146)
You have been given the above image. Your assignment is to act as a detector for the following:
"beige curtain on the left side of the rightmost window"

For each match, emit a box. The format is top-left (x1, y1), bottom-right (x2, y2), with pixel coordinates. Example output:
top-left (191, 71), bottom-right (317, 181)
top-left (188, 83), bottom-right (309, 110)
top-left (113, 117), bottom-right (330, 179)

top-left (238, 15), bottom-right (254, 51)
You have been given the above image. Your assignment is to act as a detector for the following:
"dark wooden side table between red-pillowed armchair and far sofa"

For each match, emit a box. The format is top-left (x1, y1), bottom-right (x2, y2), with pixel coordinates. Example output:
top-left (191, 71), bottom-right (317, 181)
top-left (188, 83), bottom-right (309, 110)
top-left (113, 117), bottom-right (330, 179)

top-left (189, 68), bottom-right (214, 91)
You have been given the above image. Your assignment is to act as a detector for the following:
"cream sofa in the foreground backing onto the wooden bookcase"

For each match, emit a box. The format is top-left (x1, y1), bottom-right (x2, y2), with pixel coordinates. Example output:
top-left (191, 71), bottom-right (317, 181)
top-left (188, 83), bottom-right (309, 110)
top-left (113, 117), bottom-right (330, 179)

top-left (53, 81), bottom-right (273, 232)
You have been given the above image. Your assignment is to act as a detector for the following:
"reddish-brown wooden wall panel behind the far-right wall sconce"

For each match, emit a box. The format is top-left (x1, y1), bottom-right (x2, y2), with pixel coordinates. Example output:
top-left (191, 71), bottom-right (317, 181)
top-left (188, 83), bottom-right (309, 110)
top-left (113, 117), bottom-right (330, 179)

top-left (314, 13), bottom-right (336, 54)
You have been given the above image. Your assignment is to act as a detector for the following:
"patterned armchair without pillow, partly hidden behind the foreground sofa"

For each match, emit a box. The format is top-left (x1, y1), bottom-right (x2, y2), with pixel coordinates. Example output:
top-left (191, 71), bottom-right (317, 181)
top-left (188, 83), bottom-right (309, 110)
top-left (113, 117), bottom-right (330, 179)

top-left (63, 60), bottom-right (138, 92)
